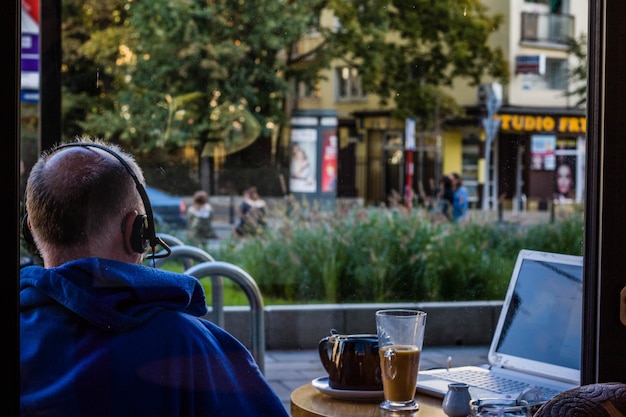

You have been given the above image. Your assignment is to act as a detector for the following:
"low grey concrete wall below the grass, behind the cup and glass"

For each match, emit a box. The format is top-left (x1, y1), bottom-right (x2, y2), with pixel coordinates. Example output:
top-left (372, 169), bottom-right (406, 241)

top-left (207, 301), bottom-right (502, 350)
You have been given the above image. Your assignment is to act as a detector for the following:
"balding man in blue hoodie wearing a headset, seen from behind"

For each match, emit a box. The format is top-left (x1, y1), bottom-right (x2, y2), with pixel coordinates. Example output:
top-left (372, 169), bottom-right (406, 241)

top-left (20, 139), bottom-right (287, 417)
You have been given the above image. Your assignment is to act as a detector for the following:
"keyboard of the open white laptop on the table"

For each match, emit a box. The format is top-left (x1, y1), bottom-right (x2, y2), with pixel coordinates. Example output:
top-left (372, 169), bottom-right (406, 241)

top-left (432, 369), bottom-right (558, 399)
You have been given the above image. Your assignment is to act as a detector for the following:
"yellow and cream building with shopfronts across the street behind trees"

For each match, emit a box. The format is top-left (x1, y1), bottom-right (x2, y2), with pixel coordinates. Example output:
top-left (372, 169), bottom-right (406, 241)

top-left (286, 0), bottom-right (588, 210)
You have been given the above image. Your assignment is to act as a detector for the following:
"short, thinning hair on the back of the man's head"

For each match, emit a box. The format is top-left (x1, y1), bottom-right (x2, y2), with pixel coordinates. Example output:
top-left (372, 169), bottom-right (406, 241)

top-left (26, 137), bottom-right (145, 247)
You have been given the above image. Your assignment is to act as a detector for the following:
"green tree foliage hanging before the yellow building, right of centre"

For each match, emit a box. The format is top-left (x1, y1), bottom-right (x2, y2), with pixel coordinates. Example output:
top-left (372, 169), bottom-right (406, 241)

top-left (291, 0), bottom-right (508, 125)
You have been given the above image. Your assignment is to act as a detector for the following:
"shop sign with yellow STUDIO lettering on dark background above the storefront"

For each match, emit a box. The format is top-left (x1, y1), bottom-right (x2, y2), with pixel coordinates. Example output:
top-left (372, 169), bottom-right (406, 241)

top-left (494, 114), bottom-right (587, 134)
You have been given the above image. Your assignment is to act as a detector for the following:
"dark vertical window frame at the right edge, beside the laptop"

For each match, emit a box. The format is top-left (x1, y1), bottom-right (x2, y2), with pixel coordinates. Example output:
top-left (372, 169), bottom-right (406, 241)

top-left (581, 0), bottom-right (626, 384)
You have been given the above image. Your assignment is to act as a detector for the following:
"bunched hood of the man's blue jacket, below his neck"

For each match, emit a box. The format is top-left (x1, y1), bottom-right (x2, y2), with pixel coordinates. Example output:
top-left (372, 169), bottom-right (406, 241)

top-left (20, 258), bottom-right (208, 332)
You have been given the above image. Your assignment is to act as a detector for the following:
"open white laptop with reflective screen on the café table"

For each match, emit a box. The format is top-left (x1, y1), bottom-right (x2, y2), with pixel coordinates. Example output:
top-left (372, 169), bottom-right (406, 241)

top-left (417, 249), bottom-right (583, 403)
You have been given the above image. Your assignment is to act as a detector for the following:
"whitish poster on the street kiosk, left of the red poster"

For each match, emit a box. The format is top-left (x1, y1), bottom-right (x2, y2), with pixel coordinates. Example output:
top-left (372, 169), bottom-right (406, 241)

top-left (289, 129), bottom-right (317, 193)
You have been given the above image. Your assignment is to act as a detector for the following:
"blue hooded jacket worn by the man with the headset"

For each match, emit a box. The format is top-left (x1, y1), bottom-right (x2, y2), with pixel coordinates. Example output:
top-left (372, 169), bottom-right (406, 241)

top-left (20, 258), bottom-right (288, 417)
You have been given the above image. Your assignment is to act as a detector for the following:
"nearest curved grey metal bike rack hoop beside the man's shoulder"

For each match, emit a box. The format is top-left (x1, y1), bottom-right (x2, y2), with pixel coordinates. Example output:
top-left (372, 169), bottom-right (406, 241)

top-left (185, 261), bottom-right (265, 373)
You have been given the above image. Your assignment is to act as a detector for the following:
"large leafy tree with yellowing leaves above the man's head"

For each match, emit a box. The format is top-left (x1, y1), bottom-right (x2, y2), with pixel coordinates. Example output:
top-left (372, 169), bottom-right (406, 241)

top-left (66, 0), bottom-right (311, 192)
